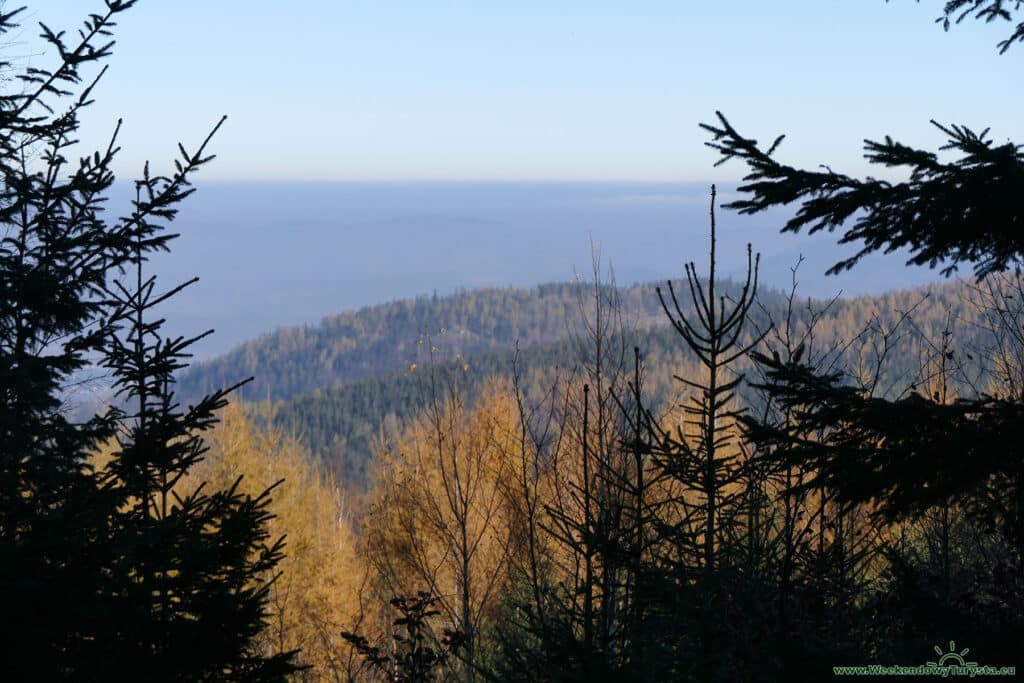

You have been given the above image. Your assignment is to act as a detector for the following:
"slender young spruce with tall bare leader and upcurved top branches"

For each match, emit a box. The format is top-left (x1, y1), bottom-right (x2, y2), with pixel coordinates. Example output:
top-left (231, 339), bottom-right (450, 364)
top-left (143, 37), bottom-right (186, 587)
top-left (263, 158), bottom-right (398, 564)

top-left (645, 185), bottom-right (761, 681)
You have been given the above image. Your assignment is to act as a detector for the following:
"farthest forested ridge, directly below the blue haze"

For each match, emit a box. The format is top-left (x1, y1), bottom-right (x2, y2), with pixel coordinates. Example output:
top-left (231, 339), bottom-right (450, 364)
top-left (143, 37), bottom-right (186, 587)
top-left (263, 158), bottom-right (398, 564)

top-left (178, 278), bottom-right (969, 400)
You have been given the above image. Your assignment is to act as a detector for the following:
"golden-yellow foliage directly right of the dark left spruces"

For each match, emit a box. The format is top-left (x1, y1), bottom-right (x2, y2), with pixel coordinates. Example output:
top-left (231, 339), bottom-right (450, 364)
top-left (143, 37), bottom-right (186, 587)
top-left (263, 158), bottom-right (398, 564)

top-left (188, 403), bottom-right (364, 681)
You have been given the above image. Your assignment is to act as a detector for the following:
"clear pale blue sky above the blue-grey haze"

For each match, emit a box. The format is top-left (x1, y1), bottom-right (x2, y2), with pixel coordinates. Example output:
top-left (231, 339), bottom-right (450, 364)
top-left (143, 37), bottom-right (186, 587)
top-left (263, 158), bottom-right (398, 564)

top-left (25, 0), bottom-right (1024, 181)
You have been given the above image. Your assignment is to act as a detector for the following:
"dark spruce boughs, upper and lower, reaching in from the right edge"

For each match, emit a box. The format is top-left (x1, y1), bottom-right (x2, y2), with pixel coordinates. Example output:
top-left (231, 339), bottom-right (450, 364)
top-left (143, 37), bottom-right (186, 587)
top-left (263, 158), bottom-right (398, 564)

top-left (701, 0), bottom-right (1024, 557)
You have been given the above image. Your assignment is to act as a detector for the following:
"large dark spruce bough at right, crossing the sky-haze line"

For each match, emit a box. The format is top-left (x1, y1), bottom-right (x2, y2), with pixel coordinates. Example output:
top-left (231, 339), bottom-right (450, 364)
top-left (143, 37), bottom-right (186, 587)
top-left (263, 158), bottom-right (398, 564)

top-left (701, 112), bottom-right (1024, 278)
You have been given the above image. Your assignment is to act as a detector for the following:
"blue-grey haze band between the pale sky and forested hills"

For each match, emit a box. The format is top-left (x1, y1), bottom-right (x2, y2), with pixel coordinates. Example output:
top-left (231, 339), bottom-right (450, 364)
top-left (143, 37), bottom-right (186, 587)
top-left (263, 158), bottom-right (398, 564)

top-left (142, 178), bottom-right (942, 360)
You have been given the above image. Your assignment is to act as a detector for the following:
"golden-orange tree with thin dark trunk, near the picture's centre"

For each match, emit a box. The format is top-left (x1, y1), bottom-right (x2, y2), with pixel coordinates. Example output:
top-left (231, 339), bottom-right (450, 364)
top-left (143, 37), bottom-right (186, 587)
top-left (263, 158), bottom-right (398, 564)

top-left (365, 381), bottom-right (518, 681)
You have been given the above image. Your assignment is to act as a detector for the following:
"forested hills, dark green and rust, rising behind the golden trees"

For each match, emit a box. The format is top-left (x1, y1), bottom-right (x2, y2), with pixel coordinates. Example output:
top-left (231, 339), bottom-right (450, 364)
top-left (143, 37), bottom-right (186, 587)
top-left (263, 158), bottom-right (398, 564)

top-left (220, 281), bottom-right (979, 488)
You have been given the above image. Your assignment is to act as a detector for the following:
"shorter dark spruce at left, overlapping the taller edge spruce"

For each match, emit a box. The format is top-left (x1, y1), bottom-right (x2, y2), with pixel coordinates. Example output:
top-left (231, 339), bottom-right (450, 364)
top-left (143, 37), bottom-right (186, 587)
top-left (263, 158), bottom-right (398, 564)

top-left (97, 153), bottom-right (296, 681)
